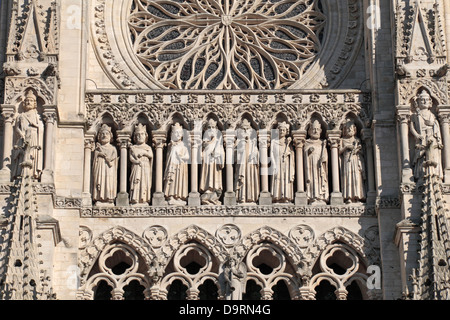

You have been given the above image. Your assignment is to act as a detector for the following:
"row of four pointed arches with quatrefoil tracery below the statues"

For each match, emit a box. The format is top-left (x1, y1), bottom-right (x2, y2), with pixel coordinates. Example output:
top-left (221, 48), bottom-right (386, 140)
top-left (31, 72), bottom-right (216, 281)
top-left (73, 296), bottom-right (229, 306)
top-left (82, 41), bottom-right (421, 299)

top-left (78, 225), bottom-right (379, 300)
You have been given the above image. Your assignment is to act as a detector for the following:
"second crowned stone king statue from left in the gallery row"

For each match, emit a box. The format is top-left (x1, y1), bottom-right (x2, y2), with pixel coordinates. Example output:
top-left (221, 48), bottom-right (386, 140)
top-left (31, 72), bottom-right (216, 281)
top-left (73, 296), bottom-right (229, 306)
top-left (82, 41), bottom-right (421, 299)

top-left (130, 124), bottom-right (153, 204)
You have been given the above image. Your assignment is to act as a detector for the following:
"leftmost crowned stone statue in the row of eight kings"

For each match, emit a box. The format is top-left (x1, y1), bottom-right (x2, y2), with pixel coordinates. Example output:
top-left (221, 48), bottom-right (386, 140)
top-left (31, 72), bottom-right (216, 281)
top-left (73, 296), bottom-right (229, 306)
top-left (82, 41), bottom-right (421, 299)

top-left (93, 124), bottom-right (119, 205)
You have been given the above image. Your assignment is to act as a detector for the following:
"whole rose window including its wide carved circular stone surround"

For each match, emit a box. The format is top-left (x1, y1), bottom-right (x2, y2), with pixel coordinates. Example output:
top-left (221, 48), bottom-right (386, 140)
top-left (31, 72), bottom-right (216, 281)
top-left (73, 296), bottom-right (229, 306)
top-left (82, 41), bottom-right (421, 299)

top-left (91, 0), bottom-right (363, 89)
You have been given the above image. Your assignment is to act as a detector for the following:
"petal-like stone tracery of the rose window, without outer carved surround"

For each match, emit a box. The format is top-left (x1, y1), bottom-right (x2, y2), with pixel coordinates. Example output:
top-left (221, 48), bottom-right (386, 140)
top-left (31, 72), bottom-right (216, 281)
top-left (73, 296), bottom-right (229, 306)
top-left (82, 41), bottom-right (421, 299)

top-left (128, 0), bottom-right (326, 89)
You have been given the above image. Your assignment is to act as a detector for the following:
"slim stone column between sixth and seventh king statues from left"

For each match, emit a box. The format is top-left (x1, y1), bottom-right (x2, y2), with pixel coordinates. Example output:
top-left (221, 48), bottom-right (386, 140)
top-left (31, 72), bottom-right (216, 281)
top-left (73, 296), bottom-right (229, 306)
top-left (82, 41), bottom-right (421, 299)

top-left (292, 130), bottom-right (308, 206)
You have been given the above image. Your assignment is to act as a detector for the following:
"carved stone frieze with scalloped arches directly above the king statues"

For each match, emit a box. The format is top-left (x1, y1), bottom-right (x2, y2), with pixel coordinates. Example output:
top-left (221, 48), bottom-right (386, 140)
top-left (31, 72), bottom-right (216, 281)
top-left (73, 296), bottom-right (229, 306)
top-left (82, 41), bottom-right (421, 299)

top-left (86, 91), bottom-right (372, 130)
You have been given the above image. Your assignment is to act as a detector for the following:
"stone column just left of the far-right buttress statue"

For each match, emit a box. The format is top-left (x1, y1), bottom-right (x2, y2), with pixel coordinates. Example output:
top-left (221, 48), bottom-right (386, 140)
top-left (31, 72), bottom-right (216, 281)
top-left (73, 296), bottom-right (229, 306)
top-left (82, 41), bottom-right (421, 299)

top-left (397, 106), bottom-right (414, 183)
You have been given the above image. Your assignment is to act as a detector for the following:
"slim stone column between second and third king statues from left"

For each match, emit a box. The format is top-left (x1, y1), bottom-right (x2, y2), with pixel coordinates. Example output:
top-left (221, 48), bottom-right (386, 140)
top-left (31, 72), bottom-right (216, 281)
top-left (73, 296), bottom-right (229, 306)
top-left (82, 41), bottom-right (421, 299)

top-left (152, 131), bottom-right (167, 206)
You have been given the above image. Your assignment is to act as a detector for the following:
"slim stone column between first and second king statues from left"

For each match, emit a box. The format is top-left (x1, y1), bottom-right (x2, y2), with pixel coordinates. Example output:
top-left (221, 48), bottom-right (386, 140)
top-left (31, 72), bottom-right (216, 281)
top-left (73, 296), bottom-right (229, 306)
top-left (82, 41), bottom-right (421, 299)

top-left (116, 131), bottom-right (131, 206)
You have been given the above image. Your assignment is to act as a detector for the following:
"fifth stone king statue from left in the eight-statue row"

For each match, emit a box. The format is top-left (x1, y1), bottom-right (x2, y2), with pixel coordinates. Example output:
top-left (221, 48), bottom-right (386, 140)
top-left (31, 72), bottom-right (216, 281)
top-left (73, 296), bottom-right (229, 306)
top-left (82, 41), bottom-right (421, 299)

top-left (234, 119), bottom-right (259, 204)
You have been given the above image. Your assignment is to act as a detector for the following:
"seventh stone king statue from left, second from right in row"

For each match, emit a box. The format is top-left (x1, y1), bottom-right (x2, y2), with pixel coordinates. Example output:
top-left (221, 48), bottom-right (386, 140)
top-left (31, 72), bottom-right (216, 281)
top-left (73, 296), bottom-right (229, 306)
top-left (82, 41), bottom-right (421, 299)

top-left (304, 120), bottom-right (329, 205)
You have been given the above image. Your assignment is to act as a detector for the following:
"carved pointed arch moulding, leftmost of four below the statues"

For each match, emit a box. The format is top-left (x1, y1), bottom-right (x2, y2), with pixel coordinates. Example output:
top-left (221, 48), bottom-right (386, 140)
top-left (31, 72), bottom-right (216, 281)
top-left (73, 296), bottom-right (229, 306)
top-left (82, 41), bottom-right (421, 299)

top-left (79, 226), bottom-right (156, 285)
